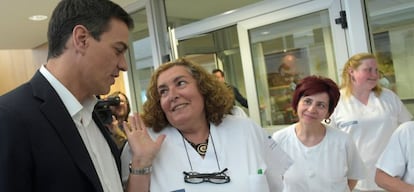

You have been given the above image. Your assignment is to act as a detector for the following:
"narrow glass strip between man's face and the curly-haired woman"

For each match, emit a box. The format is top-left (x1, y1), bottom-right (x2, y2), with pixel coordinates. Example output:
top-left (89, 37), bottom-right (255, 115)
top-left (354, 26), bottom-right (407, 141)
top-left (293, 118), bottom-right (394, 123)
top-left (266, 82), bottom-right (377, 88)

top-left (129, 9), bottom-right (154, 111)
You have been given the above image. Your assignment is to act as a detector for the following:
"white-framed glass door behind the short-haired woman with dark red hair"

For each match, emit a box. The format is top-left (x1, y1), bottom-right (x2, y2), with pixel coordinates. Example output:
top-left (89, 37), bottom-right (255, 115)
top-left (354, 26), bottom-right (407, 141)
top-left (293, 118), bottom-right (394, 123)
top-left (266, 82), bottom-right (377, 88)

top-left (238, 0), bottom-right (348, 130)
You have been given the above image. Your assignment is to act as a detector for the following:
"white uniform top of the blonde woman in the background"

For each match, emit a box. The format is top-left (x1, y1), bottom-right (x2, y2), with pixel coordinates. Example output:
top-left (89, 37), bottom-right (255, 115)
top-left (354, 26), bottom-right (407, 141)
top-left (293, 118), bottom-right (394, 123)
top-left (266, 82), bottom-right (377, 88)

top-left (331, 88), bottom-right (412, 190)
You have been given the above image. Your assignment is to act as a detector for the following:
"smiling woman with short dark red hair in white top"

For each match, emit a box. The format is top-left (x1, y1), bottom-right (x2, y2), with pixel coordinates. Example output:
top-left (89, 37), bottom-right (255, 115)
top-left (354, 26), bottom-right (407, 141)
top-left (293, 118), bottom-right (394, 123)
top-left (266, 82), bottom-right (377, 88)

top-left (273, 76), bottom-right (364, 192)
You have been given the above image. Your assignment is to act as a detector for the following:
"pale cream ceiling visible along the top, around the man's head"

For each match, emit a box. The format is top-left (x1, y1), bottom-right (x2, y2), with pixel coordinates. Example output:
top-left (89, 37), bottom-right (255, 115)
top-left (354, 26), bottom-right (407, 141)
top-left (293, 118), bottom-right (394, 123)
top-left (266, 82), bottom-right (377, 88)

top-left (0, 0), bottom-right (261, 50)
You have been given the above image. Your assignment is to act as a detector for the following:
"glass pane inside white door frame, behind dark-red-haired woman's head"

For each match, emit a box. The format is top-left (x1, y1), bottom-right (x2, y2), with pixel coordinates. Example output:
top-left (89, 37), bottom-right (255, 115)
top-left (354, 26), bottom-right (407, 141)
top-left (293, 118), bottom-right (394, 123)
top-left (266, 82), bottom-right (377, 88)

top-left (249, 10), bottom-right (336, 127)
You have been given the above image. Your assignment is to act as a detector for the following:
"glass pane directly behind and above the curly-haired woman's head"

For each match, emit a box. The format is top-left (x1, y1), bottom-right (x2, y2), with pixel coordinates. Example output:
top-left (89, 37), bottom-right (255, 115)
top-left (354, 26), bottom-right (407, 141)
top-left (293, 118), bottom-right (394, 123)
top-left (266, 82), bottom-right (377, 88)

top-left (178, 26), bottom-right (247, 112)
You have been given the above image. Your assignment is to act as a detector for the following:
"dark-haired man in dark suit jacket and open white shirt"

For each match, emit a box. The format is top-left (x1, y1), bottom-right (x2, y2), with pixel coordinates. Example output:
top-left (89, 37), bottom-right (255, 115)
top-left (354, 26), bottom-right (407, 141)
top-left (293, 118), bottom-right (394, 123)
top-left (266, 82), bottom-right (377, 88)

top-left (0, 0), bottom-right (148, 192)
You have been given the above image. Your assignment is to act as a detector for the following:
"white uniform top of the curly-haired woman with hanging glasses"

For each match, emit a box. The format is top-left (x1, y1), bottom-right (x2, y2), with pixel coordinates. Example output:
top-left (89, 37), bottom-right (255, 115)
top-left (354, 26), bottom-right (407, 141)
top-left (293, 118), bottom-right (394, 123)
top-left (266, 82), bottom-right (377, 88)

top-left (121, 115), bottom-right (287, 192)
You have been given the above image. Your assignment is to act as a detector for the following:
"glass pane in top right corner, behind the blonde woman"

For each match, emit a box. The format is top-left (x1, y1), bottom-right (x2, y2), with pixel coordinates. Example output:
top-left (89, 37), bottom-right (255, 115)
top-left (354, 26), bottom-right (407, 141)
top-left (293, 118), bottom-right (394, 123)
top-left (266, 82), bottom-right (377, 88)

top-left (365, 0), bottom-right (414, 105)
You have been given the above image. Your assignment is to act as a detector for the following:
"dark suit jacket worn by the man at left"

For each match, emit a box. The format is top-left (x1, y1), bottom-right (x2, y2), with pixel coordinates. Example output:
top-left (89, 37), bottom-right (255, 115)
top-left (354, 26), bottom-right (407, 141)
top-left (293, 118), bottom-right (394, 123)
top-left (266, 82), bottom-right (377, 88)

top-left (0, 71), bottom-right (121, 192)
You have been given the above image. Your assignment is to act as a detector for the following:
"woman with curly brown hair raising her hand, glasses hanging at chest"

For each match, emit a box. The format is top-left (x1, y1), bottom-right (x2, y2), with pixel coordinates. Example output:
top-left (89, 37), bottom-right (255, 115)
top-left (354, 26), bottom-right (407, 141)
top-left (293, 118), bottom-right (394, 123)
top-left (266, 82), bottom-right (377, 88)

top-left (122, 59), bottom-right (289, 192)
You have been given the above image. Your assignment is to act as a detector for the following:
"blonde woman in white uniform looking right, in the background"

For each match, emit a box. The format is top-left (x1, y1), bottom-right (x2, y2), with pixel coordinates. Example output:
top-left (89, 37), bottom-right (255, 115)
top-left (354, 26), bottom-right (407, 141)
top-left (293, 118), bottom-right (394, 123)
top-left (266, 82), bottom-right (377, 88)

top-left (331, 53), bottom-right (412, 191)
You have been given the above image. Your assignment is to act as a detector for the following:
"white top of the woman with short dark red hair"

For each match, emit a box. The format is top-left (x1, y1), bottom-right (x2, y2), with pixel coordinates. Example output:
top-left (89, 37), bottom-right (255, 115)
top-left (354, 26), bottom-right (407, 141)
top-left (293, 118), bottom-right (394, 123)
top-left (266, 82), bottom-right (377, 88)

top-left (273, 124), bottom-right (365, 192)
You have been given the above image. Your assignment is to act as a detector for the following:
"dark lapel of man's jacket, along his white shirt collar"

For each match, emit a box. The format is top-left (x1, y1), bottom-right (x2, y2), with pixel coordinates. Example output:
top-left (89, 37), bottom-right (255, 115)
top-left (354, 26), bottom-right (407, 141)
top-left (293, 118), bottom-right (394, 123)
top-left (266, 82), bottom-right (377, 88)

top-left (31, 72), bottom-right (103, 192)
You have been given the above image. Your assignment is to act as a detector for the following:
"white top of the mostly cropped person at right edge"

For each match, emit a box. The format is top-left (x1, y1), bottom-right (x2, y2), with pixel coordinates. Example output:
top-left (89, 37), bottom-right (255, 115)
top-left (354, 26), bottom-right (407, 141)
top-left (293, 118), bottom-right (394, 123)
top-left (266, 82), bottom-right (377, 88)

top-left (377, 121), bottom-right (414, 185)
